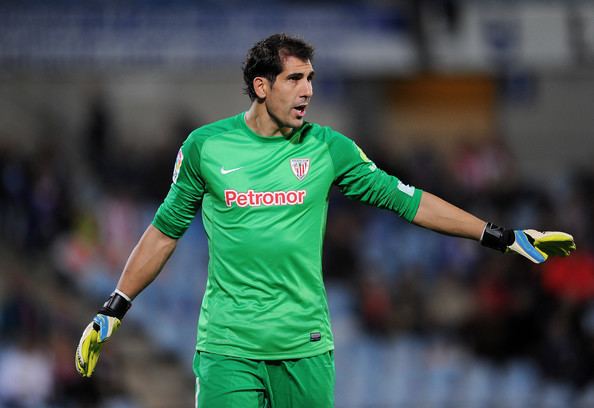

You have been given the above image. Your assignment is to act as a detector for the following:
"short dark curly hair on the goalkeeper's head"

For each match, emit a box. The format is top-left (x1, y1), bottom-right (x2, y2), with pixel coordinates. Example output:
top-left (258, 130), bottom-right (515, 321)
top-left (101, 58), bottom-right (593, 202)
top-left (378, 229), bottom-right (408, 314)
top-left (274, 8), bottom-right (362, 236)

top-left (242, 33), bottom-right (314, 101)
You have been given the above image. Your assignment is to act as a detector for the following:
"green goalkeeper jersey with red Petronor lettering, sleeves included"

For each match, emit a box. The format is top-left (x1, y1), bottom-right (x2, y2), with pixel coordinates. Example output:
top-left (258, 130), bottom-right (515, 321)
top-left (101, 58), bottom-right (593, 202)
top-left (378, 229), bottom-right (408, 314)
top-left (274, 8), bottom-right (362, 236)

top-left (153, 113), bottom-right (421, 360)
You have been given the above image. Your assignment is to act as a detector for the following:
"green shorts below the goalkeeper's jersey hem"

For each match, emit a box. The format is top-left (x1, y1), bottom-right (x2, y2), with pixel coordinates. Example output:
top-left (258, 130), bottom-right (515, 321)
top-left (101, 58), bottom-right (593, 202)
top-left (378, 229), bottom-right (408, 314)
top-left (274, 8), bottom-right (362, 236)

top-left (194, 351), bottom-right (335, 408)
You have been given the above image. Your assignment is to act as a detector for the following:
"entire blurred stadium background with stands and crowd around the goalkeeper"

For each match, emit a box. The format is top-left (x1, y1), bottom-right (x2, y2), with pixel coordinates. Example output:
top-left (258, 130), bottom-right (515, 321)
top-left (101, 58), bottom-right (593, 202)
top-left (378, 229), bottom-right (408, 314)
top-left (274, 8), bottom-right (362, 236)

top-left (0, 0), bottom-right (594, 408)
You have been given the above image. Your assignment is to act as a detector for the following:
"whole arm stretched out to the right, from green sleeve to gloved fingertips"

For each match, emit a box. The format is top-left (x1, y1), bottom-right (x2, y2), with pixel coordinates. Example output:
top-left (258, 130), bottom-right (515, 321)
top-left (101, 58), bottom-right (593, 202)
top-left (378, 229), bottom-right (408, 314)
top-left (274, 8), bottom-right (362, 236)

top-left (328, 132), bottom-right (575, 263)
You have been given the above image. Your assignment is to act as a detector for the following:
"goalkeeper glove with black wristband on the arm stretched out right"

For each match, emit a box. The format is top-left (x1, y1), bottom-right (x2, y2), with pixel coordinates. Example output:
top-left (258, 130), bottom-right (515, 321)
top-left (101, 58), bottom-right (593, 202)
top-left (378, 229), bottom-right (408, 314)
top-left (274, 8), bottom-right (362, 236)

top-left (481, 222), bottom-right (575, 263)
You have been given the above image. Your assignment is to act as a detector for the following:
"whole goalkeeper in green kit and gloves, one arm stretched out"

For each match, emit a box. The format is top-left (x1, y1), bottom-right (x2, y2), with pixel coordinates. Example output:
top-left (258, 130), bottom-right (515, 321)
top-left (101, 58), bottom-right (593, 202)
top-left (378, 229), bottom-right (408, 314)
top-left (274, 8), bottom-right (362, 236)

top-left (76, 34), bottom-right (575, 408)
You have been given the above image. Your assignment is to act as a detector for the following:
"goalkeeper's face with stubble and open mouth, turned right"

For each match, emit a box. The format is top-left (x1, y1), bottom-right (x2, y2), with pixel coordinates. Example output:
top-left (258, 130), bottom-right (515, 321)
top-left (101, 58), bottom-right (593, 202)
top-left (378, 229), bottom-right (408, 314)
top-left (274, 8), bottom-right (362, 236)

top-left (265, 56), bottom-right (314, 128)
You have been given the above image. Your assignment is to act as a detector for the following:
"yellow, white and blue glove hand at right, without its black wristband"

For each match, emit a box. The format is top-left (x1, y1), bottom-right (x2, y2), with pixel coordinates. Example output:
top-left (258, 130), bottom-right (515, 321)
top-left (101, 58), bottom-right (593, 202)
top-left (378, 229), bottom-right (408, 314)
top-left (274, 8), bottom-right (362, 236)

top-left (506, 230), bottom-right (575, 263)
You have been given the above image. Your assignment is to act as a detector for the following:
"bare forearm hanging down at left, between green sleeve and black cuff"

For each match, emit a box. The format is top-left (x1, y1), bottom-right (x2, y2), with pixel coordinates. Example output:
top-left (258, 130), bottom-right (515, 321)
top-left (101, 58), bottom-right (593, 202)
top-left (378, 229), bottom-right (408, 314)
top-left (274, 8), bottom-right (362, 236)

top-left (117, 225), bottom-right (177, 299)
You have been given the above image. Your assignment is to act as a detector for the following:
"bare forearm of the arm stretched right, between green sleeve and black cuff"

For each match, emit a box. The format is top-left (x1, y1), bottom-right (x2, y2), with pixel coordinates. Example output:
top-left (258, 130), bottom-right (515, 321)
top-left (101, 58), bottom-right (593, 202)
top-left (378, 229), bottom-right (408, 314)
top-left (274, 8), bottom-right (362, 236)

top-left (412, 191), bottom-right (487, 241)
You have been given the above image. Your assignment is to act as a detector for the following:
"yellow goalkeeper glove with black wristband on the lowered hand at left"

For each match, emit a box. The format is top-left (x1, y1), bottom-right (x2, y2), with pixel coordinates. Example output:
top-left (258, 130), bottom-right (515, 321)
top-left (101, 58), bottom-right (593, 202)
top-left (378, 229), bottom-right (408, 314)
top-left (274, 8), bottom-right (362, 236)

top-left (75, 289), bottom-right (132, 377)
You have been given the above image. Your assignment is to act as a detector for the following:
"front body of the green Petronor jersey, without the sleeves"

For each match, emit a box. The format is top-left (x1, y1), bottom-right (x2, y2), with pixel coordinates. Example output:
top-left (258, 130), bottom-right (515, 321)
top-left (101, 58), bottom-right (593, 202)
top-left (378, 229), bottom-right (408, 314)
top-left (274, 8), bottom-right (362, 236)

top-left (193, 122), bottom-right (334, 358)
